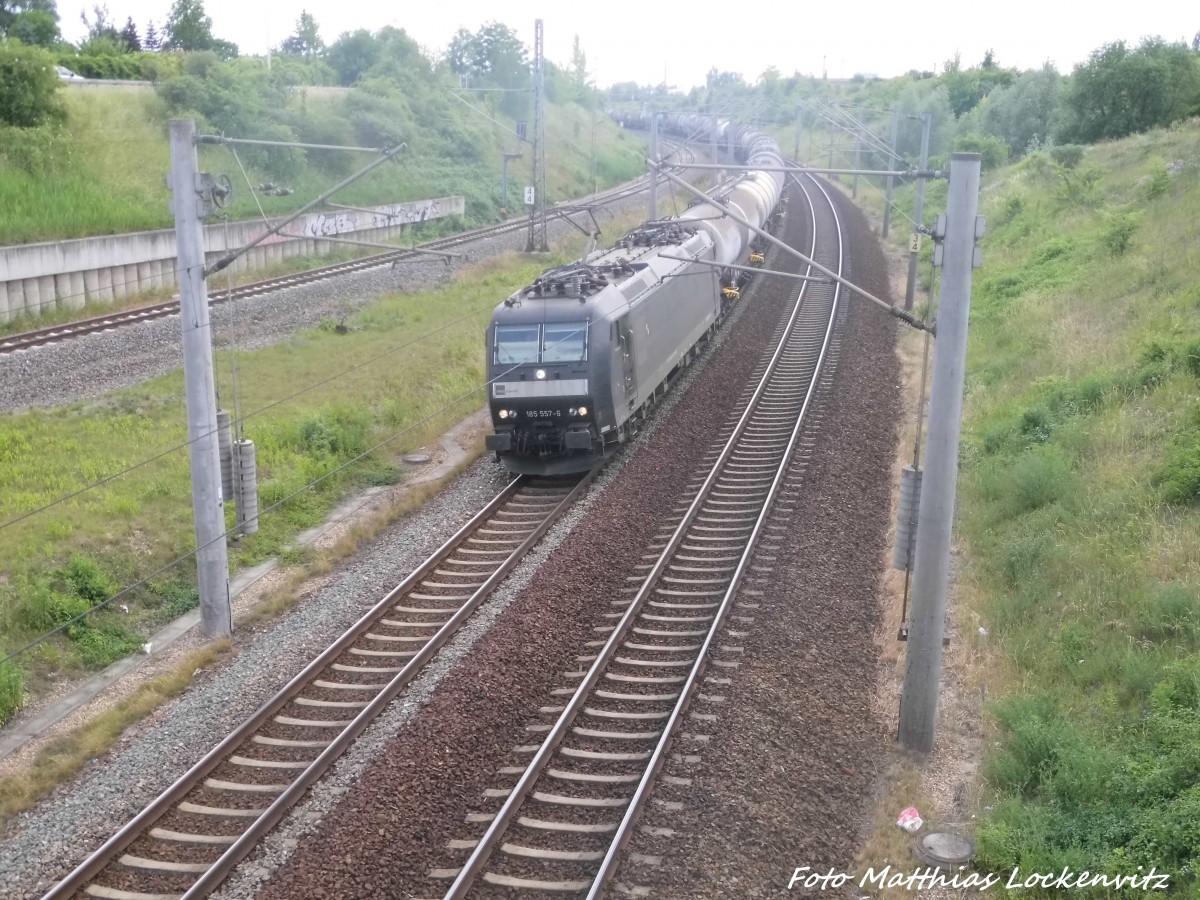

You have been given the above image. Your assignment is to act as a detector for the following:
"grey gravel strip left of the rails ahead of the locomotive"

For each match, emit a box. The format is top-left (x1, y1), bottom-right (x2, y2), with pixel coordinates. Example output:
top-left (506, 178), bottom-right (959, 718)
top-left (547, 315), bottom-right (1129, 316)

top-left (0, 462), bottom-right (508, 899)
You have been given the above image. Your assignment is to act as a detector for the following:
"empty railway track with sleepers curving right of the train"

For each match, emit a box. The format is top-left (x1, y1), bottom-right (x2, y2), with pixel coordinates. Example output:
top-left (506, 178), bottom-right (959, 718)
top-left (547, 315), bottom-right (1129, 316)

top-left (427, 170), bottom-right (842, 900)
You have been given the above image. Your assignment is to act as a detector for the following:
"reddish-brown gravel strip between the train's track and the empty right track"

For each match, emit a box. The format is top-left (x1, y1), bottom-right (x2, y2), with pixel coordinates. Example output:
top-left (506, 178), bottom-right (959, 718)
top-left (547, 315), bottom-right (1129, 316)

top-left (250, 183), bottom-right (803, 900)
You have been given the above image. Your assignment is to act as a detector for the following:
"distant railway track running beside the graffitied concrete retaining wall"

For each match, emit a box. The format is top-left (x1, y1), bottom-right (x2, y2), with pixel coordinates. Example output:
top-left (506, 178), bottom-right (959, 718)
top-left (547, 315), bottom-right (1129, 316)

top-left (0, 145), bottom-right (695, 355)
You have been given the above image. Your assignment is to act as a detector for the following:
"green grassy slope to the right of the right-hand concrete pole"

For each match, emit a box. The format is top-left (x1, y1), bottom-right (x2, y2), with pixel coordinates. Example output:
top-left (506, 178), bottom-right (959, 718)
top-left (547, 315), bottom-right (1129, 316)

top-left (854, 122), bottom-right (1200, 895)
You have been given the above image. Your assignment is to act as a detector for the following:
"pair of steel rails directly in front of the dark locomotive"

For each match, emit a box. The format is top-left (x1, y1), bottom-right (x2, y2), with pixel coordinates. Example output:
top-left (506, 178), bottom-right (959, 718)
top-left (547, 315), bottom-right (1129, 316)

top-left (43, 469), bottom-right (596, 900)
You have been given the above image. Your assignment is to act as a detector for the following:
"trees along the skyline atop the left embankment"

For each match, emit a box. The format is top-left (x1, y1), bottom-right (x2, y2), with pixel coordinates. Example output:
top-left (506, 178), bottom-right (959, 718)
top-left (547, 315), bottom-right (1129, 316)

top-left (0, 0), bottom-right (593, 135)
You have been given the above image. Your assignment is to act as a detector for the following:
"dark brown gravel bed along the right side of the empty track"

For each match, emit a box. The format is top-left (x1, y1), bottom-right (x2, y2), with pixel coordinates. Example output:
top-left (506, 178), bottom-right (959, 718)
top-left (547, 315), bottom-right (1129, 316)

top-left (618, 188), bottom-right (900, 900)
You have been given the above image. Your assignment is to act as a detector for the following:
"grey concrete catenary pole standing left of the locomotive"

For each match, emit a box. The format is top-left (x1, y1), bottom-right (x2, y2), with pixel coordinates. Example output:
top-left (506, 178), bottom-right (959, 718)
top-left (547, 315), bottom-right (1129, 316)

top-left (170, 119), bottom-right (233, 637)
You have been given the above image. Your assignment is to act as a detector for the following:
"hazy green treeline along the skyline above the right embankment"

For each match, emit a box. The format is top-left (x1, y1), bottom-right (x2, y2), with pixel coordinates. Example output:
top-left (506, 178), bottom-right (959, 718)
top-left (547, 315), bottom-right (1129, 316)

top-left (610, 35), bottom-right (1200, 166)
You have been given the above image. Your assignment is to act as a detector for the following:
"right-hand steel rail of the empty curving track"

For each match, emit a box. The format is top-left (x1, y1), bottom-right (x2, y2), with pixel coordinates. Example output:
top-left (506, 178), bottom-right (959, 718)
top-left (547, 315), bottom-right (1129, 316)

top-left (587, 169), bottom-right (845, 900)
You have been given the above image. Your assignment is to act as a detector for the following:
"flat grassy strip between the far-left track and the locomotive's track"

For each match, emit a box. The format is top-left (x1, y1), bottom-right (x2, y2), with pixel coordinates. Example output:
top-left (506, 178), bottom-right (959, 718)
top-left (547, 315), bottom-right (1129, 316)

top-left (0, 204), bottom-right (652, 716)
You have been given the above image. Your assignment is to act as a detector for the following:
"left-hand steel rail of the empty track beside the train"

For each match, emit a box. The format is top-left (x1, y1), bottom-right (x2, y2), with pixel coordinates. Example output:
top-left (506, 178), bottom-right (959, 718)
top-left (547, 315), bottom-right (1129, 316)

top-left (443, 169), bottom-right (833, 900)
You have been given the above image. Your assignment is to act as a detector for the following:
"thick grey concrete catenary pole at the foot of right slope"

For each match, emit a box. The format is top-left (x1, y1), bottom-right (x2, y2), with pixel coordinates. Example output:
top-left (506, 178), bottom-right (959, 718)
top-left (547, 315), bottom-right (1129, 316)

top-left (900, 154), bottom-right (980, 754)
